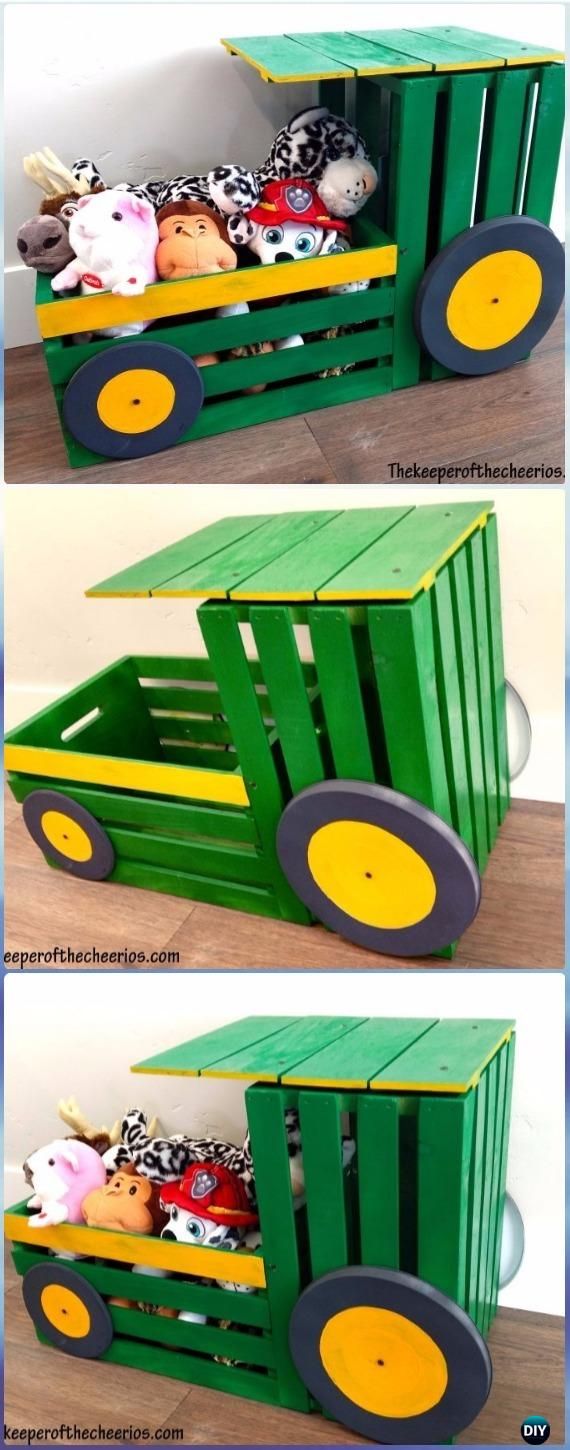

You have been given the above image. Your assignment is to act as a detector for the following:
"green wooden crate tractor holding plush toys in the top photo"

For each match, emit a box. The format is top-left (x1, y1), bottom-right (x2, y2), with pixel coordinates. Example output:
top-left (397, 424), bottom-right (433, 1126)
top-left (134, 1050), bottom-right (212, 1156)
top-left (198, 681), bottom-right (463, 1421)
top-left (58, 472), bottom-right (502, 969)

top-left (36, 26), bottom-right (564, 467)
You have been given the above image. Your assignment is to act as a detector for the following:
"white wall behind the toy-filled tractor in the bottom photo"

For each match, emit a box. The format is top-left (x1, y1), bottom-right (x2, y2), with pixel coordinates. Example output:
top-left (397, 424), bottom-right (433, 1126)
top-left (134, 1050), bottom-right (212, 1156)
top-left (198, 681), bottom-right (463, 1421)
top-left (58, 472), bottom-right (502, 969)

top-left (4, 972), bottom-right (564, 1314)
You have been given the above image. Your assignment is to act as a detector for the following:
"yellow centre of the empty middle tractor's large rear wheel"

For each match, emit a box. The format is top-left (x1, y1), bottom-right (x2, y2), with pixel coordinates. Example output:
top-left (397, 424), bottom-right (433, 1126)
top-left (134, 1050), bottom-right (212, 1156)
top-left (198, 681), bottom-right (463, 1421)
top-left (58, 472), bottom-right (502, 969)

top-left (307, 821), bottom-right (437, 931)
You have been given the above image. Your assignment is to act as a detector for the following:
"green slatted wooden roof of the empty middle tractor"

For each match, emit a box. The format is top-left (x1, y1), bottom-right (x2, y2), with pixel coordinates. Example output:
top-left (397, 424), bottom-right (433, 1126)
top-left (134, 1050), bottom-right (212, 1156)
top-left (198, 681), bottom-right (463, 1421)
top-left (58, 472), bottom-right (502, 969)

top-left (87, 502), bottom-right (493, 602)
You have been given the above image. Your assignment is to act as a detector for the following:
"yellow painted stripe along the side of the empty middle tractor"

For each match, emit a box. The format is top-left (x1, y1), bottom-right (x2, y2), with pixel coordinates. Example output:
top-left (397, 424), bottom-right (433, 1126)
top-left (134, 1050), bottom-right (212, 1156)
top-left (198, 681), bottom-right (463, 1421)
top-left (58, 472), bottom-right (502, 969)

top-left (4, 745), bottom-right (249, 806)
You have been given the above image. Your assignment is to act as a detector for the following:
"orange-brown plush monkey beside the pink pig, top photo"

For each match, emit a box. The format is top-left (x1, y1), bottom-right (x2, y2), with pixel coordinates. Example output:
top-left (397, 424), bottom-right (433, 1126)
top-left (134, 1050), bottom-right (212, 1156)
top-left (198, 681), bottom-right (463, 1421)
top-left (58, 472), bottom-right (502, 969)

top-left (157, 202), bottom-right (238, 281)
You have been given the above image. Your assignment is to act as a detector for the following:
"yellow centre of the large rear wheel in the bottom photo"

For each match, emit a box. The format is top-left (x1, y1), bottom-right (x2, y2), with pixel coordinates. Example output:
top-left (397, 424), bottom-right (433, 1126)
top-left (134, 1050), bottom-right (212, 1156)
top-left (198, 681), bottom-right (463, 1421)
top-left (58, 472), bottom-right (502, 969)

top-left (319, 1305), bottom-right (448, 1420)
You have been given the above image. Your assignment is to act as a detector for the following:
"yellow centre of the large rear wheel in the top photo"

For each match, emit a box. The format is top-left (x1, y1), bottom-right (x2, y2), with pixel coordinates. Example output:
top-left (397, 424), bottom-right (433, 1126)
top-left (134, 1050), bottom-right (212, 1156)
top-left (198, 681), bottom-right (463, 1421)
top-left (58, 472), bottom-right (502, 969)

top-left (447, 251), bottom-right (542, 352)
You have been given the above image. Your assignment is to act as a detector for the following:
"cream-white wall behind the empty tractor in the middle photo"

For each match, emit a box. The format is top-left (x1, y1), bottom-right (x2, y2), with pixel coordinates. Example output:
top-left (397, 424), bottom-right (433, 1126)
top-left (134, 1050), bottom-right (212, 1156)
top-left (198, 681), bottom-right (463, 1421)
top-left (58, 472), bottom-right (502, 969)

top-left (4, 484), bottom-right (564, 800)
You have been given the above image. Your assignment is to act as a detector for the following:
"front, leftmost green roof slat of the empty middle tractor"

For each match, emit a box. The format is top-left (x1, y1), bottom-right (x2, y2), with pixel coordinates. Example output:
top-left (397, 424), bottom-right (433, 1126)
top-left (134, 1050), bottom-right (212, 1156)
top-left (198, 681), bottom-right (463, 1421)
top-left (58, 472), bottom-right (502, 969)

top-left (87, 513), bottom-right (267, 597)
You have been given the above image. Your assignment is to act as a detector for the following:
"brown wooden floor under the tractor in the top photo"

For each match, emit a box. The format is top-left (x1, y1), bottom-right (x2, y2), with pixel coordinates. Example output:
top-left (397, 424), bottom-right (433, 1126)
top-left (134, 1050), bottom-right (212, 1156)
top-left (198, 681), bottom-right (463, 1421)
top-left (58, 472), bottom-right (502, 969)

top-left (4, 313), bottom-right (564, 484)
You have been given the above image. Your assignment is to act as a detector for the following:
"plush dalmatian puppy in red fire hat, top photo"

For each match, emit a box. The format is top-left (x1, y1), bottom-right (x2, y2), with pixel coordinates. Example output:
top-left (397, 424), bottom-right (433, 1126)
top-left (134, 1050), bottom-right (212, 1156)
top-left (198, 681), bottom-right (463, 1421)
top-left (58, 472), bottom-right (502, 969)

top-left (228, 177), bottom-right (350, 265)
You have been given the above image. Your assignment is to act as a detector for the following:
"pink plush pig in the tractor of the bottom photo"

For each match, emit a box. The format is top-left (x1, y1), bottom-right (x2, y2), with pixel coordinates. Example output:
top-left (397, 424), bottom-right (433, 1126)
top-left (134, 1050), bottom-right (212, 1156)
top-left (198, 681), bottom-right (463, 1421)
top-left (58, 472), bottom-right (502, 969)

top-left (23, 1138), bottom-right (107, 1228)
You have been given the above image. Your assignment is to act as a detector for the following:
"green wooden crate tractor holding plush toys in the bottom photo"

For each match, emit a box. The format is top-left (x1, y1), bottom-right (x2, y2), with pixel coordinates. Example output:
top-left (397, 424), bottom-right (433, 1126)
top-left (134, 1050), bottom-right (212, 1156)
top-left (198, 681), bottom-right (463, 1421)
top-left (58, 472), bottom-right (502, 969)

top-left (6, 1016), bottom-right (515, 1444)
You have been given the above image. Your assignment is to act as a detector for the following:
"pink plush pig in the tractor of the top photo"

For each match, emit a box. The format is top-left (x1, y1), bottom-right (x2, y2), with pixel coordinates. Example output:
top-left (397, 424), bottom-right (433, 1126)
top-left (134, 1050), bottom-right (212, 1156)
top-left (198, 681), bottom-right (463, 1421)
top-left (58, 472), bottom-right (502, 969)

top-left (52, 190), bottom-right (158, 338)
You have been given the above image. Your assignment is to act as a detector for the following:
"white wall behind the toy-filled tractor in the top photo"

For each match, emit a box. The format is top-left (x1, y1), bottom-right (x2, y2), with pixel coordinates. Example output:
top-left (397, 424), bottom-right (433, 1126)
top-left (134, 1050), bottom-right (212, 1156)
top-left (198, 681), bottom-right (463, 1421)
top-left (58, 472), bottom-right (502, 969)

top-left (4, 0), bottom-right (564, 347)
